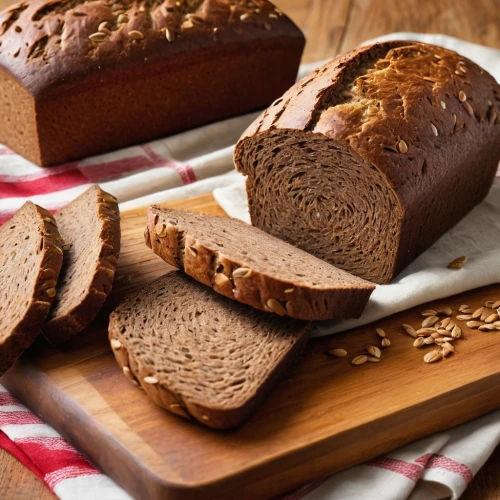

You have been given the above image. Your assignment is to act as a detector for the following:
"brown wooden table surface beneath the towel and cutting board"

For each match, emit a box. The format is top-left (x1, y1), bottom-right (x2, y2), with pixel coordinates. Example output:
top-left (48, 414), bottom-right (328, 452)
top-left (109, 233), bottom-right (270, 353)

top-left (0, 0), bottom-right (500, 500)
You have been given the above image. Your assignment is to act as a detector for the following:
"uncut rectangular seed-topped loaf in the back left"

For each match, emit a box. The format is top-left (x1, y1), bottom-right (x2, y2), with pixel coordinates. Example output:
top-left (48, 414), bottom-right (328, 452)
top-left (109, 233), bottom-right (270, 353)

top-left (0, 0), bottom-right (304, 166)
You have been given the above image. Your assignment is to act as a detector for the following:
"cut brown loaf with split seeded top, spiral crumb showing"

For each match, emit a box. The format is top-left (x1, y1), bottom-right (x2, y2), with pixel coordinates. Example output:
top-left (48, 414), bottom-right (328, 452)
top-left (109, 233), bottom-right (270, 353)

top-left (235, 41), bottom-right (500, 283)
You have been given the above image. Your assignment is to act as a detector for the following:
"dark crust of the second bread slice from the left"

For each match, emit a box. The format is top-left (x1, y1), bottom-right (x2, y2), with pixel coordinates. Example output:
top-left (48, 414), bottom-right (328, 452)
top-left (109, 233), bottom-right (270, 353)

top-left (43, 186), bottom-right (121, 346)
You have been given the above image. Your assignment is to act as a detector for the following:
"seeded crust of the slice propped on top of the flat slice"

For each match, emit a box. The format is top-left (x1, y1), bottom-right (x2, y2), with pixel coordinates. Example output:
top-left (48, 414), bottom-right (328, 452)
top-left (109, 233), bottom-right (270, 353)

top-left (145, 206), bottom-right (375, 321)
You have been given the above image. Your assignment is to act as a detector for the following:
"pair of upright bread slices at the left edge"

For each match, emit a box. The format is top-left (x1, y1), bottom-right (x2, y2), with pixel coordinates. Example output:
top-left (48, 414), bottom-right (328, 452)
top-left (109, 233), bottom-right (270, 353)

top-left (0, 186), bottom-right (120, 375)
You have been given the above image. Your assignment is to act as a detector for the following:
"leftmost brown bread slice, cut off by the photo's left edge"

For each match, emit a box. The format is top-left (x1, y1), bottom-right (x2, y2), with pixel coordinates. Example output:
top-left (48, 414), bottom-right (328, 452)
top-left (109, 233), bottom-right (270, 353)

top-left (0, 202), bottom-right (63, 375)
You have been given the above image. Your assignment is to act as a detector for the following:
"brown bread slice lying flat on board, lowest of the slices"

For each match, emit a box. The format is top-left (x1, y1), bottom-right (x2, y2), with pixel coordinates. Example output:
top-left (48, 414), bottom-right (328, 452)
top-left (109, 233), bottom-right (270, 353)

top-left (109, 272), bottom-right (310, 429)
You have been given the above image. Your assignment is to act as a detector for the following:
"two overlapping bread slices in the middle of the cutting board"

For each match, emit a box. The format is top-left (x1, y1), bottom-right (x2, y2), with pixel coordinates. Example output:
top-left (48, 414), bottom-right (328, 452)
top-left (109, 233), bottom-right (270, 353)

top-left (109, 206), bottom-right (374, 429)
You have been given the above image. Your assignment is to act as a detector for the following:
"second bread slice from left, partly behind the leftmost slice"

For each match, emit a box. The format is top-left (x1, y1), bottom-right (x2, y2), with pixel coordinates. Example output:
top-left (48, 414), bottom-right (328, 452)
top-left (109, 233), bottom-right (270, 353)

top-left (43, 185), bottom-right (120, 345)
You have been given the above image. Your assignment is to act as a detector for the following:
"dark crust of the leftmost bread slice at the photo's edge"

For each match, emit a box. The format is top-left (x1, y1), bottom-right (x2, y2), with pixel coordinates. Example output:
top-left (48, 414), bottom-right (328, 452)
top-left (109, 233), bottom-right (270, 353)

top-left (0, 202), bottom-right (63, 375)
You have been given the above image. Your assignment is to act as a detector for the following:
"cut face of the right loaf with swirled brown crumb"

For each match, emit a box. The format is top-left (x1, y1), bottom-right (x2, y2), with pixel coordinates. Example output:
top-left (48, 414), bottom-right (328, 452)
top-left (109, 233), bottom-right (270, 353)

top-left (236, 130), bottom-right (401, 283)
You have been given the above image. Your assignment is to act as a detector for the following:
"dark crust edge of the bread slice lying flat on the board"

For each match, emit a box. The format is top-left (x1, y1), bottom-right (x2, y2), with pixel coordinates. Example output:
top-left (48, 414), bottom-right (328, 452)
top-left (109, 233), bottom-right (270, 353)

top-left (109, 274), bottom-right (312, 430)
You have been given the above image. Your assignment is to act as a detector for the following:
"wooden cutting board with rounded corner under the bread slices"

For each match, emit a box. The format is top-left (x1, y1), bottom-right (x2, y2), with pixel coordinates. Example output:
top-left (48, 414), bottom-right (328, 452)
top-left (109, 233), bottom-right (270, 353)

top-left (0, 195), bottom-right (500, 499)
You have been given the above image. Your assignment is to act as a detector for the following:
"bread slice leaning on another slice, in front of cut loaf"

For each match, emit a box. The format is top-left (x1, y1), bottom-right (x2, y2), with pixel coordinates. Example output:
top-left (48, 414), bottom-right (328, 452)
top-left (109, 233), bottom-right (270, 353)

top-left (145, 206), bottom-right (375, 320)
